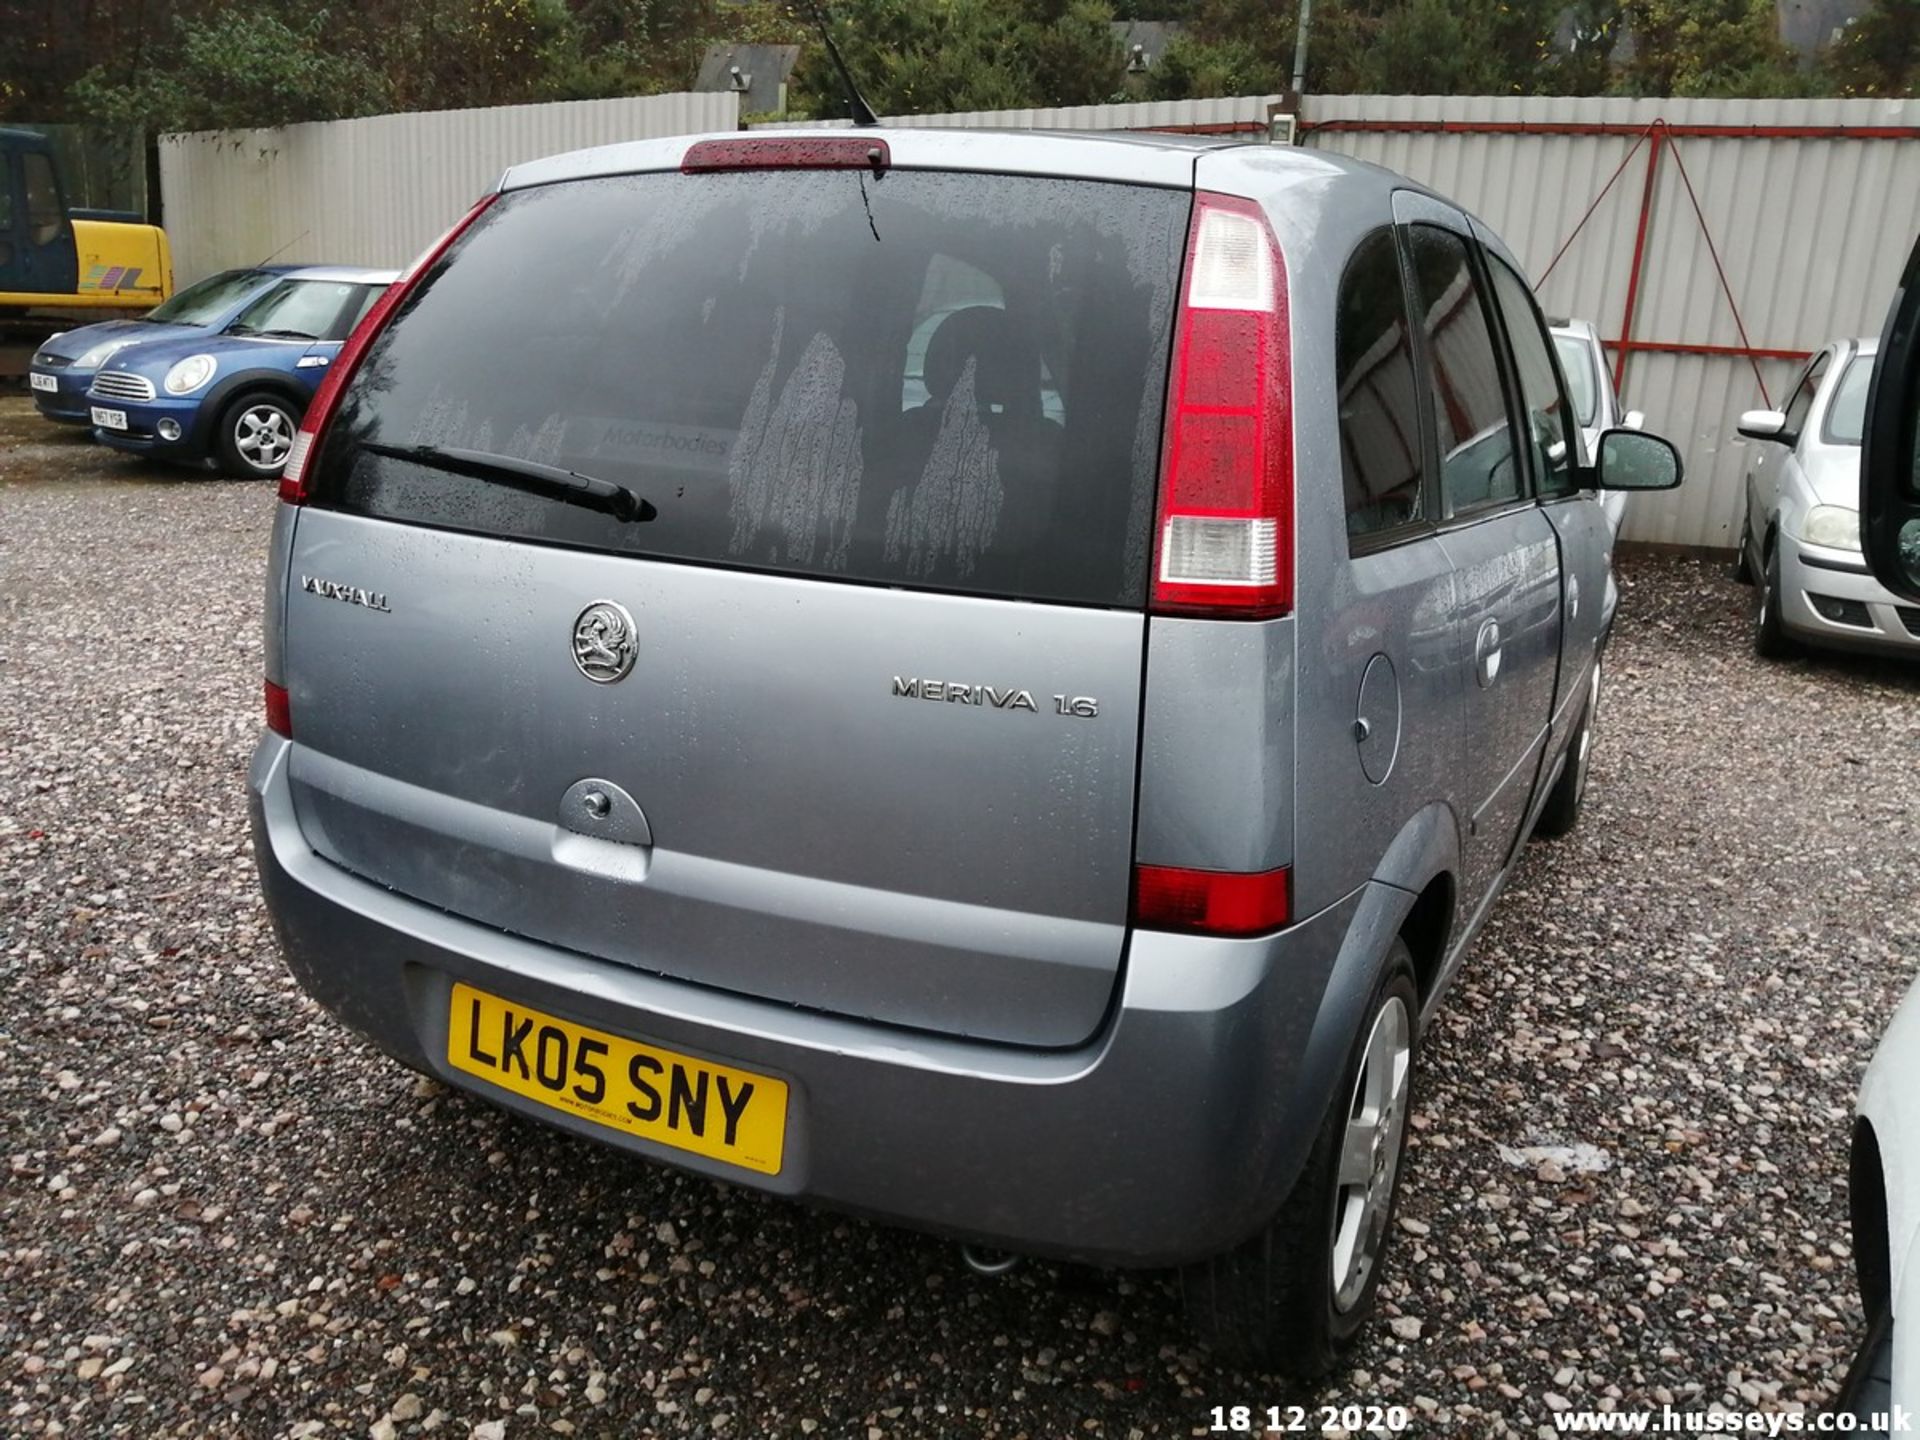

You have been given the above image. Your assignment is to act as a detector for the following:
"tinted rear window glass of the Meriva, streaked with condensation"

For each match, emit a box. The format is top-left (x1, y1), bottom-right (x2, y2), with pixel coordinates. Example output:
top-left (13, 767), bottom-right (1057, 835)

top-left (315, 171), bottom-right (1190, 605)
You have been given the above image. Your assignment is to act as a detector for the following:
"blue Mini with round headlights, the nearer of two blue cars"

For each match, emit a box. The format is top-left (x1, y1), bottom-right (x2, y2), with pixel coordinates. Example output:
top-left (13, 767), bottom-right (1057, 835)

top-left (86, 267), bottom-right (396, 480)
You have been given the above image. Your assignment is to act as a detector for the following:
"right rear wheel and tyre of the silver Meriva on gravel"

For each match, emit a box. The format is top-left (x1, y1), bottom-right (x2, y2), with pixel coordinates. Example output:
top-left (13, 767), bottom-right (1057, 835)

top-left (1181, 937), bottom-right (1419, 1380)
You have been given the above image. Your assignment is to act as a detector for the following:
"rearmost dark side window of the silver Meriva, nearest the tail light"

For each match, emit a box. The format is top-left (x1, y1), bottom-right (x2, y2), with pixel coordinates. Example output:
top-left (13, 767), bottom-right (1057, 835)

top-left (1336, 228), bottom-right (1425, 540)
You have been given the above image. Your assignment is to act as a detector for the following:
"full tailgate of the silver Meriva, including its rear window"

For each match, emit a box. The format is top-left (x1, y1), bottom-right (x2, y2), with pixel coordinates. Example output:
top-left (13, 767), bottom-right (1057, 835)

top-left (286, 155), bottom-right (1190, 1046)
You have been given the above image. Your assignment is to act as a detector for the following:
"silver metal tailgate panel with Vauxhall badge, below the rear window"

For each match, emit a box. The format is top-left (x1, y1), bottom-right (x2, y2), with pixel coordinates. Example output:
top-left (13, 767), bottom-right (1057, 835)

top-left (288, 515), bottom-right (1142, 1044)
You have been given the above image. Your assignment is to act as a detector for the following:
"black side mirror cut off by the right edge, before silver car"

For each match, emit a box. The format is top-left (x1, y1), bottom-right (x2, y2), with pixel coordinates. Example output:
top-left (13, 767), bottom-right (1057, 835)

top-left (1860, 232), bottom-right (1920, 601)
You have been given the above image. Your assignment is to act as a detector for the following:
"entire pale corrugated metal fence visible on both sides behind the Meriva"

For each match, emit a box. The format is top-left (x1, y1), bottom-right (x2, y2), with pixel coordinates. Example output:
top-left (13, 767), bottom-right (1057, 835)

top-left (161, 94), bottom-right (1920, 545)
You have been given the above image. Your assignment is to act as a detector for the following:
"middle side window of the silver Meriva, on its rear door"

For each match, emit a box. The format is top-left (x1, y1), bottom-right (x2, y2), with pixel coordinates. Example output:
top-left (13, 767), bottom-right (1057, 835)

top-left (1407, 225), bottom-right (1523, 513)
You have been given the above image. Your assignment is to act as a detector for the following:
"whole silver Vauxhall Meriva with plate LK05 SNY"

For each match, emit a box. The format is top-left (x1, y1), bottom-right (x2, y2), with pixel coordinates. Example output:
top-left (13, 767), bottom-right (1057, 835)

top-left (250, 131), bottom-right (1678, 1375)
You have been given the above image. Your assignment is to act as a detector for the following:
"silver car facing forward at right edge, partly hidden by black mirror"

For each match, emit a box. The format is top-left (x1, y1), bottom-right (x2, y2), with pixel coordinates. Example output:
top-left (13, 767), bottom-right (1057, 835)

top-left (1736, 340), bottom-right (1920, 659)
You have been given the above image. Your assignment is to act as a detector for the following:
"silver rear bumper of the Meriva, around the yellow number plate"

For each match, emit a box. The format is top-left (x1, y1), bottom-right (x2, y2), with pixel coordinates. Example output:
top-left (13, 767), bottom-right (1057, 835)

top-left (250, 735), bottom-right (1398, 1265)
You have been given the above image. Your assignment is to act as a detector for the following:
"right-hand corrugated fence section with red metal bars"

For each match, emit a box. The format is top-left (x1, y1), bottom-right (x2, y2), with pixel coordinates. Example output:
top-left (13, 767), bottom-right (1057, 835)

top-left (1304, 96), bottom-right (1920, 547)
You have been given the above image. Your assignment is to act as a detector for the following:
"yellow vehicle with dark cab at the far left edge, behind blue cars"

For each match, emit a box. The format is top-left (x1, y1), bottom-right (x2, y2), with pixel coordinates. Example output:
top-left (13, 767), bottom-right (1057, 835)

top-left (0, 129), bottom-right (173, 321)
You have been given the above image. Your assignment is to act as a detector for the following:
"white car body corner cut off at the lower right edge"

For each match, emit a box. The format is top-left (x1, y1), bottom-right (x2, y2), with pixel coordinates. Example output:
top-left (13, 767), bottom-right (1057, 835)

top-left (1839, 983), bottom-right (1920, 1428)
